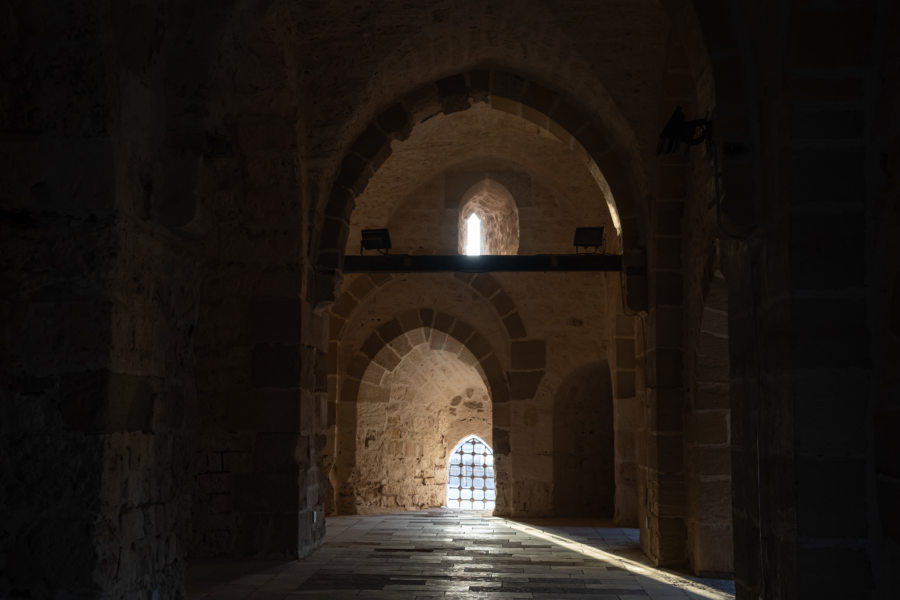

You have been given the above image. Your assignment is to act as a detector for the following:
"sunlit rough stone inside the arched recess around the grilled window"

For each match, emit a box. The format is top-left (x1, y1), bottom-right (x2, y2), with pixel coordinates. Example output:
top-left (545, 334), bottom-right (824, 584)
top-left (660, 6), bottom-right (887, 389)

top-left (351, 340), bottom-right (492, 513)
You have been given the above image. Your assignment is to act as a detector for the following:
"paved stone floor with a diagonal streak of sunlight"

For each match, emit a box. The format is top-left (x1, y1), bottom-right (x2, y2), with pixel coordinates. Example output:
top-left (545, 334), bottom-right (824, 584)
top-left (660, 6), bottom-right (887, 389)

top-left (187, 509), bottom-right (734, 600)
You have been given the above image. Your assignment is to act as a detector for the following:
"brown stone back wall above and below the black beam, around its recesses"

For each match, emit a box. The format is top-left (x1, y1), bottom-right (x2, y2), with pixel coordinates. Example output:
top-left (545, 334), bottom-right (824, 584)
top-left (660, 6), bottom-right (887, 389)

top-left (326, 105), bottom-right (637, 522)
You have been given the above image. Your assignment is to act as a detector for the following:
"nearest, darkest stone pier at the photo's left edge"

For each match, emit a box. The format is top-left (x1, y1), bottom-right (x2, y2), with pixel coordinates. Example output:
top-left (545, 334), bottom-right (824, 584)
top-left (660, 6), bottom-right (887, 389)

top-left (0, 3), bottom-right (194, 597)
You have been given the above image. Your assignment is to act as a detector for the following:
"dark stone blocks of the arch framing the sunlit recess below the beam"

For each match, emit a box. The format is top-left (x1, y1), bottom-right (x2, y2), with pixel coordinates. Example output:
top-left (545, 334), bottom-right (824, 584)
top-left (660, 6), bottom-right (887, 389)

top-left (317, 273), bottom-right (546, 514)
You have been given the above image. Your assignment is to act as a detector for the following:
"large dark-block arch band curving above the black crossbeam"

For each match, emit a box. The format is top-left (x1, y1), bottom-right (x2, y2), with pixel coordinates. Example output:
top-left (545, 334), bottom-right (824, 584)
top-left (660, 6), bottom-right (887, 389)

top-left (316, 68), bottom-right (646, 308)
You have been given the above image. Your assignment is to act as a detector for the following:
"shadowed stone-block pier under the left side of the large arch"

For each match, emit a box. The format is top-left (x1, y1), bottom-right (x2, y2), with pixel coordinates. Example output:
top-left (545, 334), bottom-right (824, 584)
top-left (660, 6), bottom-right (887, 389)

top-left (183, 36), bottom-right (325, 557)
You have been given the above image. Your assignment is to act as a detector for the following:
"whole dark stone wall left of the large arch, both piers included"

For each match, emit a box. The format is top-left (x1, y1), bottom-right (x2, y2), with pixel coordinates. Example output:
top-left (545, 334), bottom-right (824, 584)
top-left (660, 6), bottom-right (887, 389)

top-left (0, 3), bottom-right (324, 597)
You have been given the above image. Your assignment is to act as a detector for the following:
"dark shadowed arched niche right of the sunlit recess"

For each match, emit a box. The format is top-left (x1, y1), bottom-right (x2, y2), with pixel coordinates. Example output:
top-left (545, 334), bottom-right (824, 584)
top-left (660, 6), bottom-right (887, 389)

top-left (553, 362), bottom-right (615, 518)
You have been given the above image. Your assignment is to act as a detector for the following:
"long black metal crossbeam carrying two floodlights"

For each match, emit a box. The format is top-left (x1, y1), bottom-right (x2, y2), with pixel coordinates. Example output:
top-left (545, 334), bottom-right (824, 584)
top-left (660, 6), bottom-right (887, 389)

top-left (344, 254), bottom-right (622, 273)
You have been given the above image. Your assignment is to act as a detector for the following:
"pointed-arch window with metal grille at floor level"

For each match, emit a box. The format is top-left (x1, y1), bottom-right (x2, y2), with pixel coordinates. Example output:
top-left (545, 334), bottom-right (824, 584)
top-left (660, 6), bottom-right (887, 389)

top-left (447, 435), bottom-right (497, 510)
